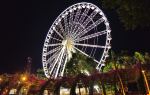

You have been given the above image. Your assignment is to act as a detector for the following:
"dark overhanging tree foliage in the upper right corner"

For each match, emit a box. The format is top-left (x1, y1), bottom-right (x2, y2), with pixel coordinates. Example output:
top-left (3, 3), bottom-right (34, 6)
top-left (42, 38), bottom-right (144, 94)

top-left (102, 0), bottom-right (150, 30)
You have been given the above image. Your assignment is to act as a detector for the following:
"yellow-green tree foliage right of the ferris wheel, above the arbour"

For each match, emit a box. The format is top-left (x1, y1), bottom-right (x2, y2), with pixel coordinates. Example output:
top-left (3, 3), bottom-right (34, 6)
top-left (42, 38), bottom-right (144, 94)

top-left (103, 51), bottom-right (150, 72)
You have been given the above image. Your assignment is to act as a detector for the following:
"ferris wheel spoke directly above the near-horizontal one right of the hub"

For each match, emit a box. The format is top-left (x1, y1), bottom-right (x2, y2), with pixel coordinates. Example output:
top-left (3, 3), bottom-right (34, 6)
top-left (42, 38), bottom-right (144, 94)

top-left (74, 30), bottom-right (107, 42)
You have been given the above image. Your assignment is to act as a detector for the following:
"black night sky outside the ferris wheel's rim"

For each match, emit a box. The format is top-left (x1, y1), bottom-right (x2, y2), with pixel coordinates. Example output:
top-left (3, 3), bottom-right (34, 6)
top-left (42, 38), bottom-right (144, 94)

top-left (0, 0), bottom-right (150, 73)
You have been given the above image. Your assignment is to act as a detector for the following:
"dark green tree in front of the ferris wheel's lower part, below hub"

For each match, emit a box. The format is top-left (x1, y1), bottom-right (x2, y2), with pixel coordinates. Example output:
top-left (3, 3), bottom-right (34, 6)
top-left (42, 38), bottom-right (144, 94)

top-left (65, 52), bottom-right (96, 76)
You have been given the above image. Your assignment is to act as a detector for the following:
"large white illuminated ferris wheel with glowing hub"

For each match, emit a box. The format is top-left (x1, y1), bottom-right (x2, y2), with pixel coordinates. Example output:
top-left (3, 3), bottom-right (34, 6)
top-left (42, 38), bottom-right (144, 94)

top-left (42, 2), bottom-right (111, 78)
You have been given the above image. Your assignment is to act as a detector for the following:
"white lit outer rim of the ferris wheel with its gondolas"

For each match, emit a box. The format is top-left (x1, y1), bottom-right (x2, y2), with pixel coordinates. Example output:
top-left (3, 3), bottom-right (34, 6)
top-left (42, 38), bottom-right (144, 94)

top-left (42, 2), bottom-right (111, 77)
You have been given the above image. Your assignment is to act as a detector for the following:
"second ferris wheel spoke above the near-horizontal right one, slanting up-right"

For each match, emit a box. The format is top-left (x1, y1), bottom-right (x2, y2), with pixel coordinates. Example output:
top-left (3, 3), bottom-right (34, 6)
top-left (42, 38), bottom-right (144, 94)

top-left (76, 18), bottom-right (104, 37)
